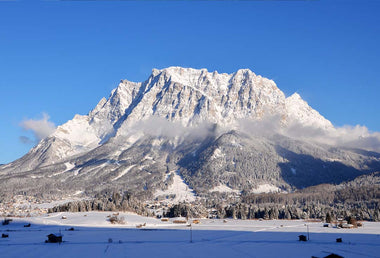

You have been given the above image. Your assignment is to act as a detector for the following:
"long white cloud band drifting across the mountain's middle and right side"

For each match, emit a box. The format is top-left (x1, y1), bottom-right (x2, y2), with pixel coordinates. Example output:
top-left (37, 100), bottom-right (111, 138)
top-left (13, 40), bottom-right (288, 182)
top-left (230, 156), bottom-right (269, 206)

top-left (124, 115), bottom-right (380, 152)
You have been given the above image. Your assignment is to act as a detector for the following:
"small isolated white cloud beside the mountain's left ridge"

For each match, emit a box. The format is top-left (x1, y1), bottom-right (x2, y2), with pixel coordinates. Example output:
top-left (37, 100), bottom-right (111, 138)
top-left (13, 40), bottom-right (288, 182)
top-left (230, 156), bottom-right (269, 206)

top-left (20, 113), bottom-right (56, 142)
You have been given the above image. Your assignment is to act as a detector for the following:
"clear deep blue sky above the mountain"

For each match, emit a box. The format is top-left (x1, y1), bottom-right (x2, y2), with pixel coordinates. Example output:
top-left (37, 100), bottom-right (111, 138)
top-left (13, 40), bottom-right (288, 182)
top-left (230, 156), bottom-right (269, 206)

top-left (0, 0), bottom-right (380, 163)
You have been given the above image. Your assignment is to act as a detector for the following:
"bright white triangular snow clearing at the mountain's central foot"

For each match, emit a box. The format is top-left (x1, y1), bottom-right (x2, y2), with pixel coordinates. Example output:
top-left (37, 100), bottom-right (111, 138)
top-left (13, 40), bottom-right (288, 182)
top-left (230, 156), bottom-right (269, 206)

top-left (154, 171), bottom-right (196, 203)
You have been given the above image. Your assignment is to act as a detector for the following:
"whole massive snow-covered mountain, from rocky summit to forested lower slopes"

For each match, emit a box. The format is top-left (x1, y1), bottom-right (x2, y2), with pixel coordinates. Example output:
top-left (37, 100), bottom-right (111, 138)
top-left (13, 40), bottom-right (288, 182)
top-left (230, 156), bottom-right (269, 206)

top-left (0, 67), bottom-right (380, 200)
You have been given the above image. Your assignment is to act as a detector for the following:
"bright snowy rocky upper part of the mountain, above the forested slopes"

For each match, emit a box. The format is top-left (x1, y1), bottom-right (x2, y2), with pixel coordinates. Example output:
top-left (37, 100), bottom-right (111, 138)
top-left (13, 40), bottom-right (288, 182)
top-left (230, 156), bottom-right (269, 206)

top-left (6, 67), bottom-right (332, 171)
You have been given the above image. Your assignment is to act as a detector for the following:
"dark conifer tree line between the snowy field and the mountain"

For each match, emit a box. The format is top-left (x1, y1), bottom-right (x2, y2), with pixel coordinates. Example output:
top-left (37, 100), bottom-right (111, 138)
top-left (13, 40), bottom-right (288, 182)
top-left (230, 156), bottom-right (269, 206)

top-left (48, 185), bottom-right (380, 221)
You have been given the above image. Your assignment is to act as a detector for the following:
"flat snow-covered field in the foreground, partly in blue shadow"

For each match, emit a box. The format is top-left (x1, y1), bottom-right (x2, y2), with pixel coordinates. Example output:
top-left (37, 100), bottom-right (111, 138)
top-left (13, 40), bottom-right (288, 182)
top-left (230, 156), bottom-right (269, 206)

top-left (0, 212), bottom-right (380, 258)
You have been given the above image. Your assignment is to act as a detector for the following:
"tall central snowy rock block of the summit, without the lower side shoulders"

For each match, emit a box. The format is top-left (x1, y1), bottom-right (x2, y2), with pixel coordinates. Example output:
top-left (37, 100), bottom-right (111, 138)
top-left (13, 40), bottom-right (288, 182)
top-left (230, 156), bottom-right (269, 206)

top-left (114, 67), bottom-right (285, 131)
